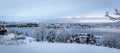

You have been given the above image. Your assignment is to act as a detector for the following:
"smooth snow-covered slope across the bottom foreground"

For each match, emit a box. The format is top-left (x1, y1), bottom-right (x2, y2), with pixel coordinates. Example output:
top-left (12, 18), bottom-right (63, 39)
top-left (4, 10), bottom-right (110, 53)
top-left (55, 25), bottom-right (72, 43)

top-left (0, 42), bottom-right (120, 53)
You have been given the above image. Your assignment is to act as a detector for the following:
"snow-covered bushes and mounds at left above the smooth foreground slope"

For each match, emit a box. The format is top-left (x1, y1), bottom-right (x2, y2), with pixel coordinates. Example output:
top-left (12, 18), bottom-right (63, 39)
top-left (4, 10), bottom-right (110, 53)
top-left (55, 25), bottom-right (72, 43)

top-left (0, 33), bottom-right (34, 45)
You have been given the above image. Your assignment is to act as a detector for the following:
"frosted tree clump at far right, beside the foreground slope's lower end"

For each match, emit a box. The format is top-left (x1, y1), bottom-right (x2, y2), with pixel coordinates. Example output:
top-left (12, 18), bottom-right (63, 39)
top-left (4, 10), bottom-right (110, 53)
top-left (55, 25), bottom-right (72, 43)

top-left (102, 34), bottom-right (120, 48)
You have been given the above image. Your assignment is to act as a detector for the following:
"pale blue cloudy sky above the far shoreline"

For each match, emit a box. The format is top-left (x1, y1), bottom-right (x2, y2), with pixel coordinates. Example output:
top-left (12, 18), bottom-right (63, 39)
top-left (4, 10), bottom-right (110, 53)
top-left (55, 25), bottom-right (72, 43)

top-left (0, 0), bottom-right (120, 22)
